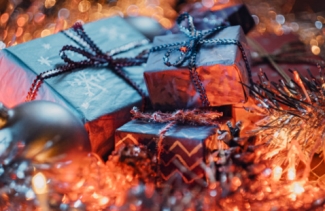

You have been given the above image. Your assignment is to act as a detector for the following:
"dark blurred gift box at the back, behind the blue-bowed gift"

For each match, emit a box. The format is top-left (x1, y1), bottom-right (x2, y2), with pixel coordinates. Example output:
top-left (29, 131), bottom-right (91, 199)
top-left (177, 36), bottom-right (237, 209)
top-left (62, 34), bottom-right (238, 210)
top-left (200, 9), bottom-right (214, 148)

top-left (172, 2), bottom-right (255, 34)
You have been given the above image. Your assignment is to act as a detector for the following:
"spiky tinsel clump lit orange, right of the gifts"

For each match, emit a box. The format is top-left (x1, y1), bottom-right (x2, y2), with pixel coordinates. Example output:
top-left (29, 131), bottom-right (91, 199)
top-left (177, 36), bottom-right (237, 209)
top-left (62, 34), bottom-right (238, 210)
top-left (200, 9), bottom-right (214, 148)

top-left (247, 67), bottom-right (324, 178)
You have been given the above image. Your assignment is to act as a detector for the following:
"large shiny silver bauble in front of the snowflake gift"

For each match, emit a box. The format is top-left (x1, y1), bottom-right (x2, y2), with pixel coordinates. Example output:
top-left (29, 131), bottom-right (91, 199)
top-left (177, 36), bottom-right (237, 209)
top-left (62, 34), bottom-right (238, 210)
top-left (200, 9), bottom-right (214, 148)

top-left (0, 101), bottom-right (91, 163)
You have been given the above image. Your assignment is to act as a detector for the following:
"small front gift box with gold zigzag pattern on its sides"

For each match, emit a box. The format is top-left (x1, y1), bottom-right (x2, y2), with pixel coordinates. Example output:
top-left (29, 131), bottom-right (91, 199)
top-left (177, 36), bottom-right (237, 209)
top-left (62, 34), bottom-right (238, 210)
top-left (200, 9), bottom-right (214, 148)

top-left (115, 120), bottom-right (227, 183)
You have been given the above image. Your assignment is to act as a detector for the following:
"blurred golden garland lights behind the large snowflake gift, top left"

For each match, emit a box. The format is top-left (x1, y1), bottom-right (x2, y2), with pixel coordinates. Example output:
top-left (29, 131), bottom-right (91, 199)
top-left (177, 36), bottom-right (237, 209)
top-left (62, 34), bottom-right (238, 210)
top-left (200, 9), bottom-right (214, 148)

top-left (0, 0), bottom-right (178, 48)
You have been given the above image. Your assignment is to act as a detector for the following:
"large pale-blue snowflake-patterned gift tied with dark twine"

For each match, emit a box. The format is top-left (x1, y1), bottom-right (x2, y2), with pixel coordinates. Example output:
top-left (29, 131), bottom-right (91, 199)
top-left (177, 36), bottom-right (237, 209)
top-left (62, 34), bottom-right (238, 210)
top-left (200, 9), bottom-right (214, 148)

top-left (0, 17), bottom-right (148, 156)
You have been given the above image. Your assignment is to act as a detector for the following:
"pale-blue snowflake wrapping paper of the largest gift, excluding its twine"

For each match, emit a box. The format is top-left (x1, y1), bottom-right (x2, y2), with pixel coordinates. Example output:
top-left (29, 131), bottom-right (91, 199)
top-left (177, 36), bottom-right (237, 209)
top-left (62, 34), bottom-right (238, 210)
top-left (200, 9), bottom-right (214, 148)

top-left (0, 17), bottom-right (148, 156)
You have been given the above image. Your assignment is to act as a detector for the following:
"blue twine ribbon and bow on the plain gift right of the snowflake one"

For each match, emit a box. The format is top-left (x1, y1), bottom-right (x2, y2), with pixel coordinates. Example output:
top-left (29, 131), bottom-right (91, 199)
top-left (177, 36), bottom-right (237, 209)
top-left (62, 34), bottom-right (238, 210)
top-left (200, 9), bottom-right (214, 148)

top-left (150, 13), bottom-right (252, 107)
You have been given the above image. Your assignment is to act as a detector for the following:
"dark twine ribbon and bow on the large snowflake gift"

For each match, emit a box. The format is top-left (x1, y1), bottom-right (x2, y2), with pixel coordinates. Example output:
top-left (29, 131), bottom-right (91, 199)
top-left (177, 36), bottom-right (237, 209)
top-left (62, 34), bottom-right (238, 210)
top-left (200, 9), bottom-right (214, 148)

top-left (26, 22), bottom-right (149, 104)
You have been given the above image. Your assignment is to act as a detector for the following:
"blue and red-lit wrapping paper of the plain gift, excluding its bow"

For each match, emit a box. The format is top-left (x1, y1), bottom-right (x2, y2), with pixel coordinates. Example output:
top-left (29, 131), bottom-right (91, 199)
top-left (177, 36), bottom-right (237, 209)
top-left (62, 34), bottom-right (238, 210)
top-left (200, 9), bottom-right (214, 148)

top-left (144, 26), bottom-right (250, 110)
